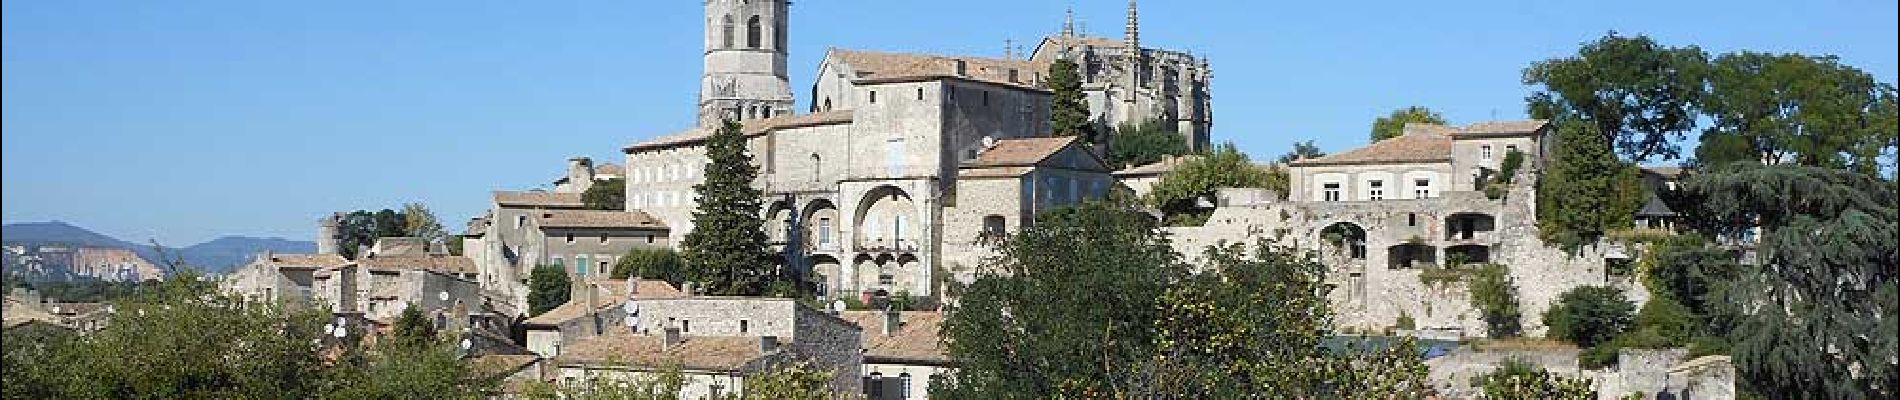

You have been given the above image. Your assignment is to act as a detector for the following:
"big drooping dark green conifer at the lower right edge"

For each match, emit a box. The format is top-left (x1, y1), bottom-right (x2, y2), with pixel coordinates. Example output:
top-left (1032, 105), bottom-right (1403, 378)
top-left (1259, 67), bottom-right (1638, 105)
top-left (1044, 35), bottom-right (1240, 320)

top-left (1683, 165), bottom-right (1900, 398)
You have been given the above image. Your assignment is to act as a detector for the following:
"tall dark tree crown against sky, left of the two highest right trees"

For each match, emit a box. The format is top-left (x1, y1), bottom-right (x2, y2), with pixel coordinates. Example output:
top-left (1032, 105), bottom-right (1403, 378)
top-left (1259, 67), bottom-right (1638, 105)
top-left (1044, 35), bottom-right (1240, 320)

top-left (1524, 32), bottom-right (1708, 163)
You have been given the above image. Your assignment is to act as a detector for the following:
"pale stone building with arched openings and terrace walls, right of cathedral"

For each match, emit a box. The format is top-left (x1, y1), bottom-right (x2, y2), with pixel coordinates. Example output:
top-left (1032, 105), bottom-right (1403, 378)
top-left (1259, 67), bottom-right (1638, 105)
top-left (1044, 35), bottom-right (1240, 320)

top-left (1170, 121), bottom-right (1647, 336)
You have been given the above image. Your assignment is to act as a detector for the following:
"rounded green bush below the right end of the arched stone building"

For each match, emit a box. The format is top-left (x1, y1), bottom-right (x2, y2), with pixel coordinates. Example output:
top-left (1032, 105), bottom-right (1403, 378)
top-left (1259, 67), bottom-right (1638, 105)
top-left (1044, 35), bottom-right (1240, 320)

top-left (1543, 286), bottom-right (1636, 347)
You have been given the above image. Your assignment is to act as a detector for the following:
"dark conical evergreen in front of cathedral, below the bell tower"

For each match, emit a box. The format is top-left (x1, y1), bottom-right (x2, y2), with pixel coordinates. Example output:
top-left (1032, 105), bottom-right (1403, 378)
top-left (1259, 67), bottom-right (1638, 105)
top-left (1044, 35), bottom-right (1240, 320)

top-left (680, 121), bottom-right (777, 296)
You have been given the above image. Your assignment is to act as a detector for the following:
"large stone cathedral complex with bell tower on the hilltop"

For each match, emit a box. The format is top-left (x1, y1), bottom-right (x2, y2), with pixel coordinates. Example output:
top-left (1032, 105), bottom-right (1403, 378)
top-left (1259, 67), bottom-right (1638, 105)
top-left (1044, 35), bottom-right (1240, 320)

top-left (623, 0), bottom-right (1212, 298)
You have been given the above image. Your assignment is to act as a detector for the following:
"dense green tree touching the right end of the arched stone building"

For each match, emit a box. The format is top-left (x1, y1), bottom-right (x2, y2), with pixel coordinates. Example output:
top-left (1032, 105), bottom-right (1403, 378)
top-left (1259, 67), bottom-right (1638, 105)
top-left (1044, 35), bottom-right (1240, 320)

top-left (1537, 121), bottom-right (1647, 248)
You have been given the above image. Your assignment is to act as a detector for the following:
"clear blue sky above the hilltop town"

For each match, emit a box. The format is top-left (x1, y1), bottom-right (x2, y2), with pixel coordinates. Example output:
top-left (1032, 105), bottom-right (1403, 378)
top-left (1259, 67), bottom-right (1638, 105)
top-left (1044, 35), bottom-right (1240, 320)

top-left (0, 0), bottom-right (1900, 245)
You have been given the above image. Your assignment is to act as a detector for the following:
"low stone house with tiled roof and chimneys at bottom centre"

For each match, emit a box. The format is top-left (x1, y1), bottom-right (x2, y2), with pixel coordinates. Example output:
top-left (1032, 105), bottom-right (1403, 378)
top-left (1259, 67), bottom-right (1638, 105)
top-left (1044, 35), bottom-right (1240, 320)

top-left (549, 296), bottom-right (863, 398)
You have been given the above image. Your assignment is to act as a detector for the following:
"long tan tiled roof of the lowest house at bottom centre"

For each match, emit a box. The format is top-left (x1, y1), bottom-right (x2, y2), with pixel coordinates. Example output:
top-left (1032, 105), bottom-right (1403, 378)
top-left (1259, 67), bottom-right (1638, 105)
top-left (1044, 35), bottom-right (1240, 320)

top-left (555, 330), bottom-right (762, 372)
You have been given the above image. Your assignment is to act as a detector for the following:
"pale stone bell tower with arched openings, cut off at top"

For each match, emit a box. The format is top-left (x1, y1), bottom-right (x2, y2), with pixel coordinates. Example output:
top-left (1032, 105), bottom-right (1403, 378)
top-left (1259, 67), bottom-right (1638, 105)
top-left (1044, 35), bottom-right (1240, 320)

top-left (699, 0), bottom-right (792, 127)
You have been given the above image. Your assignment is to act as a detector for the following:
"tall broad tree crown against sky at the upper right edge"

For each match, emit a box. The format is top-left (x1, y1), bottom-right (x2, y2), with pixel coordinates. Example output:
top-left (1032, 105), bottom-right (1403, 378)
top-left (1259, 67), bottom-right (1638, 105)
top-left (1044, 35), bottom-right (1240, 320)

top-left (1699, 51), bottom-right (1900, 174)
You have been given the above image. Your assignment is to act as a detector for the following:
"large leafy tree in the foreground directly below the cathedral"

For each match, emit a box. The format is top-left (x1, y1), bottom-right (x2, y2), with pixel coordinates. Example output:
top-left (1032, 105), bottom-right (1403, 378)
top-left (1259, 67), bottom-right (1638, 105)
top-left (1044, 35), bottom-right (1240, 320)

top-left (931, 203), bottom-right (1188, 398)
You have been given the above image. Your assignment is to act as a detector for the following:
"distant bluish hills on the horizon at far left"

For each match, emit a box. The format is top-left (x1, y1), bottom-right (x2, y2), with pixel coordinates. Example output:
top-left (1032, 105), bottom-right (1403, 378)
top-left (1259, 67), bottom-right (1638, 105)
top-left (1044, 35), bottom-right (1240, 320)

top-left (0, 222), bottom-right (317, 273)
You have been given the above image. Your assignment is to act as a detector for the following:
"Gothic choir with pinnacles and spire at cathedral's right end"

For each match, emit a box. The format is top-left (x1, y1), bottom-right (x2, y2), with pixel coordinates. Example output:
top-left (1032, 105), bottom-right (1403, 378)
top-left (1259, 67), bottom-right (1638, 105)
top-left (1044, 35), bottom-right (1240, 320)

top-left (1030, 0), bottom-right (1214, 152)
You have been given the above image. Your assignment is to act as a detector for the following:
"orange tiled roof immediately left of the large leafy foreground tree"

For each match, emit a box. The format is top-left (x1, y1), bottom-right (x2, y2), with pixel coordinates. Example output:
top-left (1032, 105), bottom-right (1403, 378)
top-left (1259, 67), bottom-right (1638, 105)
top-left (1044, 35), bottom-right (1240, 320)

top-left (838, 311), bottom-right (950, 362)
